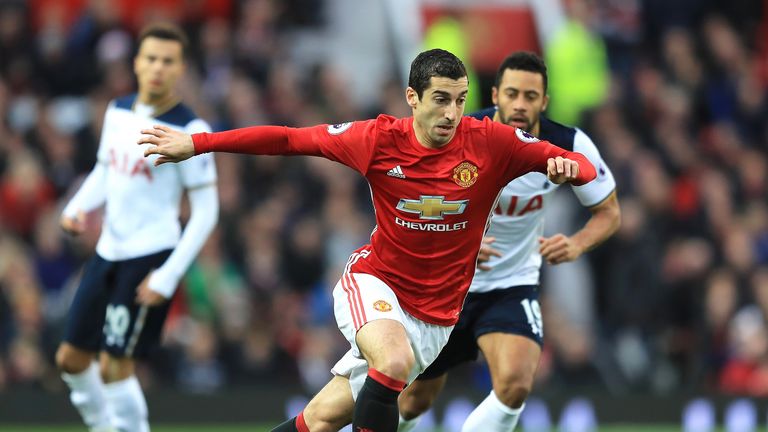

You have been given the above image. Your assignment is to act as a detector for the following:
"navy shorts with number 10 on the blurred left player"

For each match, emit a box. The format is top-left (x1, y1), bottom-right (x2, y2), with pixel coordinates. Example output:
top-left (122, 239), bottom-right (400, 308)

top-left (64, 250), bottom-right (171, 358)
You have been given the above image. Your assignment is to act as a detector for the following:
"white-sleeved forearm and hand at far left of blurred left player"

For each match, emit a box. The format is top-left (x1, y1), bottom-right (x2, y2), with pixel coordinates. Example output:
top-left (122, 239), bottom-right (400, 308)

top-left (59, 162), bottom-right (107, 236)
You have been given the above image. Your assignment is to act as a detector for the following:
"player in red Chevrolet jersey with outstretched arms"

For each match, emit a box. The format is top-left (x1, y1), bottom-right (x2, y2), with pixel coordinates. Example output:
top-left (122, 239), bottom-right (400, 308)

top-left (139, 49), bottom-right (596, 432)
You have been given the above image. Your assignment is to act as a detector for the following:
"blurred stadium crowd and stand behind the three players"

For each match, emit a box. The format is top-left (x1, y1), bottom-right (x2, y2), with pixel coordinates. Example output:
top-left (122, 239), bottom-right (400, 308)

top-left (0, 0), bottom-right (768, 430)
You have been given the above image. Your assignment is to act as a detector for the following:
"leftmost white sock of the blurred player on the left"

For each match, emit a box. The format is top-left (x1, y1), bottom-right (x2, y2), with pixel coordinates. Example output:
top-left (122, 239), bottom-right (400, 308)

top-left (61, 362), bottom-right (111, 430)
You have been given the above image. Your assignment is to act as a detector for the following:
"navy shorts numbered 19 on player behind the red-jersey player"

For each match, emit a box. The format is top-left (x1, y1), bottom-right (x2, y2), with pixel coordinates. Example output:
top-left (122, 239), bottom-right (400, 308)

top-left (416, 285), bottom-right (544, 379)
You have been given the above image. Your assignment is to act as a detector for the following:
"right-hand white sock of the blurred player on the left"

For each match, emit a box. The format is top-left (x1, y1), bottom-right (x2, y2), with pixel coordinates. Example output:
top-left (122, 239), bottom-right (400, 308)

top-left (104, 375), bottom-right (149, 432)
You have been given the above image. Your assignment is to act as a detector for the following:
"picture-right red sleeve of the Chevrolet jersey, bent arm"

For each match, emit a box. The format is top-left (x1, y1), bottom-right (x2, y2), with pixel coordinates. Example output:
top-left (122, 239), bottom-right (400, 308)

top-left (485, 119), bottom-right (597, 186)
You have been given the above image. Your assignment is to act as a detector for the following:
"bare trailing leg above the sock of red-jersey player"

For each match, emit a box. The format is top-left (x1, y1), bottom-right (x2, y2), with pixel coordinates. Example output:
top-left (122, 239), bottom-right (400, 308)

top-left (304, 376), bottom-right (355, 431)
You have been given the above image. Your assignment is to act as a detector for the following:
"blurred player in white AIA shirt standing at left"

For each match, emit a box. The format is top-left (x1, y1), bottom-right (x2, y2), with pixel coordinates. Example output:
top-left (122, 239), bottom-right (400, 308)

top-left (56, 24), bottom-right (219, 432)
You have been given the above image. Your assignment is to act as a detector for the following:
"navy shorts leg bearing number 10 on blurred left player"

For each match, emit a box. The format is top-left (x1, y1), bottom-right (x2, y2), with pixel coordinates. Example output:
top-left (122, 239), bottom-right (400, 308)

top-left (102, 251), bottom-right (170, 358)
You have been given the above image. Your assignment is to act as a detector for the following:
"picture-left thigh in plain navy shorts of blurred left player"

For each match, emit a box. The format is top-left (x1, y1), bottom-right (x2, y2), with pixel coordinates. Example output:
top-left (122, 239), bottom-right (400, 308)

top-left (62, 254), bottom-right (117, 354)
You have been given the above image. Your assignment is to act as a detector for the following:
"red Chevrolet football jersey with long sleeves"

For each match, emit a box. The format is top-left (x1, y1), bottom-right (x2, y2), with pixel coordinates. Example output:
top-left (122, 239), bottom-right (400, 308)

top-left (193, 115), bottom-right (595, 325)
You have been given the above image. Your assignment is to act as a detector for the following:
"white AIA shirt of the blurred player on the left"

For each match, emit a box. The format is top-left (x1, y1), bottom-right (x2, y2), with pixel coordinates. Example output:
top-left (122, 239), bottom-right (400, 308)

top-left (96, 94), bottom-right (216, 261)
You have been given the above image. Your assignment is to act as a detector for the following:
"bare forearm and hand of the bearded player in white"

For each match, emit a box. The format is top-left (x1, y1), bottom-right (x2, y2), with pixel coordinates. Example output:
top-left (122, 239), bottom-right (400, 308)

top-left (539, 191), bottom-right (621, 264)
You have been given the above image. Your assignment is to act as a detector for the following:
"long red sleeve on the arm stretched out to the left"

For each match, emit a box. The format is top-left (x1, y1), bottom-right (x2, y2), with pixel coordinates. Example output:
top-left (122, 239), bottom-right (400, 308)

top-left (192, 120), bottom-right (377, 175)
